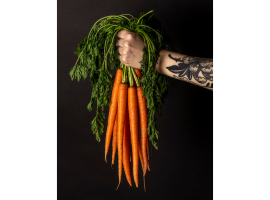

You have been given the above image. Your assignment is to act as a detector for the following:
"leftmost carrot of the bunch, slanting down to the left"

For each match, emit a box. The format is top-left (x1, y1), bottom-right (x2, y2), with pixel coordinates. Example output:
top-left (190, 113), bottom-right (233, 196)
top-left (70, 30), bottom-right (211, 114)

top-left (105, 69), bottom-right (123, 162)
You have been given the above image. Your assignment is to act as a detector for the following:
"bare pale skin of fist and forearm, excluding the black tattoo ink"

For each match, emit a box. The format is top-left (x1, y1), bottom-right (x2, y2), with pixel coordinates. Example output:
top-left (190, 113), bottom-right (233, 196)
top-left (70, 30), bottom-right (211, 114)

top-left (116, 30), bottom-right (214, 91)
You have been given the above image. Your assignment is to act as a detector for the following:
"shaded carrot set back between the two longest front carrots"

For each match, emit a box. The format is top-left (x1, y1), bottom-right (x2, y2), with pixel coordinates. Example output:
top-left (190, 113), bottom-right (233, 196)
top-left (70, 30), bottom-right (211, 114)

top-left (123, 106), bottom-right (132, 186)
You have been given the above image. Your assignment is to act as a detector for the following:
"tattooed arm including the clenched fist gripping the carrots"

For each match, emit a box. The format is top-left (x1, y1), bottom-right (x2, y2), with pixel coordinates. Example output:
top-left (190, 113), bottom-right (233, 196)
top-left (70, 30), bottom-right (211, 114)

top-left (116, 30), bottom-right (214, 91)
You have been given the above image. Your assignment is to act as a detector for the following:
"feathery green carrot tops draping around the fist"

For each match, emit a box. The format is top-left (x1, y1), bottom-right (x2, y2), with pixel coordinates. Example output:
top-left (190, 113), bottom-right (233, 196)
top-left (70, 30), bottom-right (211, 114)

top-left (69, 10), bottom-right (169, 149)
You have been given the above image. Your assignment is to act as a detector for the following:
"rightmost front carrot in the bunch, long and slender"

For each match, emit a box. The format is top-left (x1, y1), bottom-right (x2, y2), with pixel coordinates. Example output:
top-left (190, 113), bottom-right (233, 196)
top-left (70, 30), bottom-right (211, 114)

top-left (137, 87), bottom-right (148, 176)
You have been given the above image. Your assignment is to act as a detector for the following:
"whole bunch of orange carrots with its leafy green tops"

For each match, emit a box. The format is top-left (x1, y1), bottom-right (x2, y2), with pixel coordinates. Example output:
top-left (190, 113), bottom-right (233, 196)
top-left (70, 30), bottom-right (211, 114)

top-left (69, 10), bottom-right (170, 191)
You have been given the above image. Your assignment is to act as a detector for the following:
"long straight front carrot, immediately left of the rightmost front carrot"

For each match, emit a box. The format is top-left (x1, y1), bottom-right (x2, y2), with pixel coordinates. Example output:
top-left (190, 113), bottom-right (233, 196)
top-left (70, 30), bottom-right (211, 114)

top-left (128, 87), bottom-right (139, 187)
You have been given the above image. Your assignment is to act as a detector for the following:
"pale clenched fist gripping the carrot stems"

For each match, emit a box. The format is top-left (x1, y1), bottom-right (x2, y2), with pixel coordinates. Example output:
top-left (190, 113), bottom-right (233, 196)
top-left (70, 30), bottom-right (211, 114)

top-left (116, 30), bottom-right (144, 69)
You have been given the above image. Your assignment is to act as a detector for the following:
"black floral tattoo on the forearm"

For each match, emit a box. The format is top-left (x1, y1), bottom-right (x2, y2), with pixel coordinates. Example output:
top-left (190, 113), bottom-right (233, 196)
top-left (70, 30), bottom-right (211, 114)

top-left (166, 54), bottom-right (214, 89)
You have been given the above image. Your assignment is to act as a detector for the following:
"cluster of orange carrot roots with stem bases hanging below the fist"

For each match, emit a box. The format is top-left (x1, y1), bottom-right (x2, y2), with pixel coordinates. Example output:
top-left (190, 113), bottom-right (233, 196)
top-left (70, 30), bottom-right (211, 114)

top-left (105, 63), bottom-right (150, 189)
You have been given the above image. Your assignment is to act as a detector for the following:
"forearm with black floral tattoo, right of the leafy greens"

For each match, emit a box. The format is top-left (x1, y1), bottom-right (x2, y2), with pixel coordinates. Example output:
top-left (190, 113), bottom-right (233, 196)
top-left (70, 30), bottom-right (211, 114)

top-left (156, 49), bottom-right (214, 90)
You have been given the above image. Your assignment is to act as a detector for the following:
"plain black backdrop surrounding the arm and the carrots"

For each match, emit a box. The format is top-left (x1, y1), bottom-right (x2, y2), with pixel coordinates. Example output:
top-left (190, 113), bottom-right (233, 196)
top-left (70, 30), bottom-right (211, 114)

top-left (56, 0), bottom-right (214, 200)
